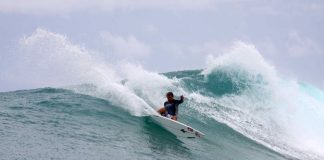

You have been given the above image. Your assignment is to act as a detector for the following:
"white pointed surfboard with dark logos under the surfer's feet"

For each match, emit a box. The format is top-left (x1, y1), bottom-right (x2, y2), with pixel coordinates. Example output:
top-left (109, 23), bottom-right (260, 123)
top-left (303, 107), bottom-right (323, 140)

top-left (151, 115), bottom-right (205, 138)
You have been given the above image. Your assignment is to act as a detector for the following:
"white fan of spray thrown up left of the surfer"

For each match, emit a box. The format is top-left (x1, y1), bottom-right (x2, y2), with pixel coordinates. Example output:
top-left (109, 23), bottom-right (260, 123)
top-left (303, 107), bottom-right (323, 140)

top-left (11, 29), bottom-right (155, 115)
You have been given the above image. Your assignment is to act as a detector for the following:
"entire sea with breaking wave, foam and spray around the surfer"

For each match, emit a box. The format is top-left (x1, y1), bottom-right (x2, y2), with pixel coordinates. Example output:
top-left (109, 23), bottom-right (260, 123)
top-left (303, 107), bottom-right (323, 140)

top-left (0, 29), bottom-right (324, 160)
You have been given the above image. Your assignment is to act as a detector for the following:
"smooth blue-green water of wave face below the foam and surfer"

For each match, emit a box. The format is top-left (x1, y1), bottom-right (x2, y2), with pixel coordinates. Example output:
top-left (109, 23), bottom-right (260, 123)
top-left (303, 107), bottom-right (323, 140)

top-left (0, 88), bottom-right (285, 159)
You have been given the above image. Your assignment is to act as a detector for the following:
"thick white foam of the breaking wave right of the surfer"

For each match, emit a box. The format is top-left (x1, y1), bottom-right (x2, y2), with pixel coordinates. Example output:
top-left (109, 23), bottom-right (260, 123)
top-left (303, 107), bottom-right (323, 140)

top-left (189, 42), bottom-right (324, 159)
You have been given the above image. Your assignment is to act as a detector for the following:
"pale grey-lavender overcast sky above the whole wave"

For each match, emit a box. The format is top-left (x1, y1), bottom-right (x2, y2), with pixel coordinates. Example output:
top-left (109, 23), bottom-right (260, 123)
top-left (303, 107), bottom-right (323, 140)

top-left (0, 0), bottom-right (324, 91)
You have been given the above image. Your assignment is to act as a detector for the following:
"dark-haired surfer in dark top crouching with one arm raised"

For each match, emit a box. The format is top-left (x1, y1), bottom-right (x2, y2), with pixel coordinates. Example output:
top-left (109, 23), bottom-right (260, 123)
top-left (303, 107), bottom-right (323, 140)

top-left (158, 92), bottom-right (184, 121)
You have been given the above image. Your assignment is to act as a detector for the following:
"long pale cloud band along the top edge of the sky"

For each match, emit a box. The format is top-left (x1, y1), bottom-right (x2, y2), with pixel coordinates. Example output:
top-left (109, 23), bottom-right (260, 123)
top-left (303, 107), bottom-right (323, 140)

top-left (0, 0), bottom-right (324, 15)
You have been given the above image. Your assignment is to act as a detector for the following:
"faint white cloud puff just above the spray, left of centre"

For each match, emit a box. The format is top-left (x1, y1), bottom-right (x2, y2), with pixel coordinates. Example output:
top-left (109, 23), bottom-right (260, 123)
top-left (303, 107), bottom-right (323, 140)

top-left (101, 32), bottom-right (151, 59)
